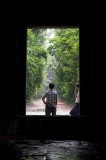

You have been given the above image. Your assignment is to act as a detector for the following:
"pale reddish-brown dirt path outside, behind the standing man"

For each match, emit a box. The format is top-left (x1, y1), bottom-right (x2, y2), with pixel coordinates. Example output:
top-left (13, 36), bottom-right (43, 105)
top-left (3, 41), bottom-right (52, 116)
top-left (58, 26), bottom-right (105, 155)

top-left (26, 99), bottom-right (72, 115)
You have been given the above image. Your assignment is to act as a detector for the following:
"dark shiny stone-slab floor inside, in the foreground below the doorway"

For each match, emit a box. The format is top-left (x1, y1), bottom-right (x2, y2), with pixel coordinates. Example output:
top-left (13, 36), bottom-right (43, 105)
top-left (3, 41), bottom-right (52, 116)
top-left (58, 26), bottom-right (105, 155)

top-left (0, 140), bottom-right (106, 160)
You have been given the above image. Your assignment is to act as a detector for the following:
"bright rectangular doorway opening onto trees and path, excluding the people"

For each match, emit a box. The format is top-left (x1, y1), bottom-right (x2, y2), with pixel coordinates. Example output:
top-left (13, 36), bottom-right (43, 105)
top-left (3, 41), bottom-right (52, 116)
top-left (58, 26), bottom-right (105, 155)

top-left (26, 27), bottom-right (80, 116)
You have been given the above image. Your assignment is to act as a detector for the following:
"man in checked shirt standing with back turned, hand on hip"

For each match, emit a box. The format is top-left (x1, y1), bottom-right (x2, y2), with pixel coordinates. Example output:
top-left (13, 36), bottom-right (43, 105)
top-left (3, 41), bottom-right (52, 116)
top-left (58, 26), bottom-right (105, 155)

top-left (42, 83), bottom-right (57, 116)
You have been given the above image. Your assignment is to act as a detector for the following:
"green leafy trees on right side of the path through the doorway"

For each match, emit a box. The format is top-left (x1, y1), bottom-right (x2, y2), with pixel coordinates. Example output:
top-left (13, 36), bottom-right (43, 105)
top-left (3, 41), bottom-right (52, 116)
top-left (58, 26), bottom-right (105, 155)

top-left (49, 28), bottom-right (79, 102)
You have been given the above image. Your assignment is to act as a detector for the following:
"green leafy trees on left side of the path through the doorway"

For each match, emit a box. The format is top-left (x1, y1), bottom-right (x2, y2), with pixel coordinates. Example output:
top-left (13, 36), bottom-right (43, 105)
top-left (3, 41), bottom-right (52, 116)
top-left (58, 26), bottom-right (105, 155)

top-left (26, 29), bottom-right (47, 101)
